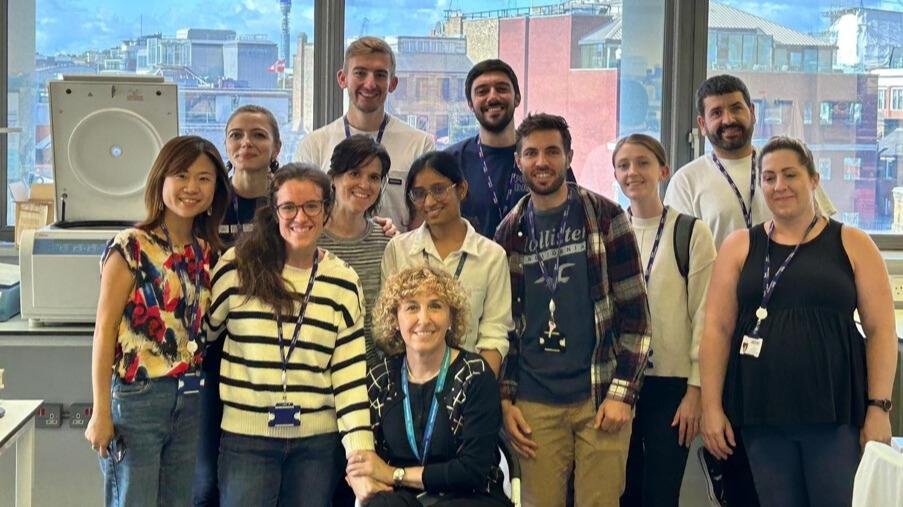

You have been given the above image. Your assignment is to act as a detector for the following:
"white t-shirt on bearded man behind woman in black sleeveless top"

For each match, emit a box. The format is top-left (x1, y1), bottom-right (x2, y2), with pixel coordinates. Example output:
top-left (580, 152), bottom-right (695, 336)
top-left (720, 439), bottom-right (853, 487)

top-left (665, 153), bottom-right (837, 248)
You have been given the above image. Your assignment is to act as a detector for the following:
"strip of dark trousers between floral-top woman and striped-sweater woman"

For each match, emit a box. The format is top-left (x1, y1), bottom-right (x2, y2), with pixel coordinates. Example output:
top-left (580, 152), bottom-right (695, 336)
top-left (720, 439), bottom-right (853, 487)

top-left (192, 339), bottom-right (225, 507)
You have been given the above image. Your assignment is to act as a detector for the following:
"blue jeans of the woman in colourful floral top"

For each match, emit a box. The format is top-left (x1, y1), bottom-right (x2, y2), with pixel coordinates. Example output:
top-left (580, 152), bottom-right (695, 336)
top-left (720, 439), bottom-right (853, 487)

top-left (100, 378), bottom-right (198, 506)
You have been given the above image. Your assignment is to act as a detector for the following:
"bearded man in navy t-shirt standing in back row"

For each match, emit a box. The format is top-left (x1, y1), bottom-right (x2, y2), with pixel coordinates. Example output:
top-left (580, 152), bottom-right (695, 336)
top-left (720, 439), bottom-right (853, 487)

top-left (446, 60), bottom-right (574, 238)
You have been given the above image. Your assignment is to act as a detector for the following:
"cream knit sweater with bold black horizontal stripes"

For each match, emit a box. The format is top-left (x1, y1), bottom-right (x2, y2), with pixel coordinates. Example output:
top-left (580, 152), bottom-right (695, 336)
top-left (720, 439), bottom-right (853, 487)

top-left (207, 248), bottom-right (373, 452)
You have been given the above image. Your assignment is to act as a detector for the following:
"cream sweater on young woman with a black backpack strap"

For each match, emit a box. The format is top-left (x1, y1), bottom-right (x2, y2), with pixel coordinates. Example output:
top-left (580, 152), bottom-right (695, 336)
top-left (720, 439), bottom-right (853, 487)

top-left (631, 209), bottom-right (715, 386)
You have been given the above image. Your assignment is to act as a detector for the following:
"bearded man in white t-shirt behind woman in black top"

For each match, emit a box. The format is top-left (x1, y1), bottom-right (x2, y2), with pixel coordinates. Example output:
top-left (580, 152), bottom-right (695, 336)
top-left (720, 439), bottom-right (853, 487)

top-left (665, 74), bottom-right (836, 248)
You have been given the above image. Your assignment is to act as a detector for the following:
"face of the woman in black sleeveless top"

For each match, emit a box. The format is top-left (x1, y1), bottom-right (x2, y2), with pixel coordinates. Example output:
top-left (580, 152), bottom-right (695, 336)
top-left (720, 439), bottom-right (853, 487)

top-left (762, 150), bottom-right (819, 218)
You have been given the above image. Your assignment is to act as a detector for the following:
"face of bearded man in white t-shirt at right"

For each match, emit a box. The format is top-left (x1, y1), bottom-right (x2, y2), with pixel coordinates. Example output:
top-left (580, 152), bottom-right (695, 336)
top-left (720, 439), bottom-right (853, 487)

top-left (696, 92), bottom-right (756, 152)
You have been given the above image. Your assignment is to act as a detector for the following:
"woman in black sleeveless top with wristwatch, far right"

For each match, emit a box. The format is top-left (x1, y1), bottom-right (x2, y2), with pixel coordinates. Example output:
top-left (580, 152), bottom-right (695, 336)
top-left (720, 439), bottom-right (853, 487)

top-left (700, 137), bottom-right (896, 506)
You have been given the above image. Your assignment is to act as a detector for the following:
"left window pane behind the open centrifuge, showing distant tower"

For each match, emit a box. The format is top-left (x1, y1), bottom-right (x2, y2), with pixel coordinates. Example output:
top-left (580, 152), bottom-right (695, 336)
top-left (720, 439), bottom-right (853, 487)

top-left (7, 0), bottom-right (313, 225)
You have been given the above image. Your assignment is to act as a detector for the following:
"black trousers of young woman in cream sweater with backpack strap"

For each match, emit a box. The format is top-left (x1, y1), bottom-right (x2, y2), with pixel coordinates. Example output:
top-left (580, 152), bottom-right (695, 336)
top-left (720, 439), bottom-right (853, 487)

top-left (621, 377), bottom-right (689, 507)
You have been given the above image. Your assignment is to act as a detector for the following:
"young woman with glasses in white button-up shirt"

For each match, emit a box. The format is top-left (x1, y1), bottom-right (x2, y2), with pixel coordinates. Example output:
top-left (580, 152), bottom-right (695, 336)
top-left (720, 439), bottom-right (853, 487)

top-left (382, 151), bottom-right (514, 375)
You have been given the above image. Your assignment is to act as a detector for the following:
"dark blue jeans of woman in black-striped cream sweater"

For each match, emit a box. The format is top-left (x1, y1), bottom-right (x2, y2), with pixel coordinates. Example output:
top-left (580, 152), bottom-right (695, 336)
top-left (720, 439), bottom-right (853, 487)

top-left (219, 431), bottom-right (342, 507)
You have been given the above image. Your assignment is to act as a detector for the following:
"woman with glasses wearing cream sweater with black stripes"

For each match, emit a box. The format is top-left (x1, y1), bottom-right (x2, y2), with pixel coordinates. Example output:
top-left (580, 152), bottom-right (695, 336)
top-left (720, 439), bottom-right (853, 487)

top-left (208, 164), bottom-right (373, 506)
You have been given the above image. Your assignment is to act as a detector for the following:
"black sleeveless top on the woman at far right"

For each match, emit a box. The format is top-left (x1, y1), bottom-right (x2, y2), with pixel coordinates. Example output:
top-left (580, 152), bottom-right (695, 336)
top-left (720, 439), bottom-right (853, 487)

top-left (724, 220), bottom-right (867, 426)
